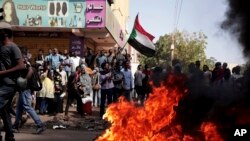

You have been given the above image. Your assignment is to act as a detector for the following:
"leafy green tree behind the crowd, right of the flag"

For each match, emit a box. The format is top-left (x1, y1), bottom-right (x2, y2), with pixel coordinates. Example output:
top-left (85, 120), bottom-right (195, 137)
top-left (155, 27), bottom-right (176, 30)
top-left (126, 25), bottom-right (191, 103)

top-left (139, 31), bottom-right (207, 71)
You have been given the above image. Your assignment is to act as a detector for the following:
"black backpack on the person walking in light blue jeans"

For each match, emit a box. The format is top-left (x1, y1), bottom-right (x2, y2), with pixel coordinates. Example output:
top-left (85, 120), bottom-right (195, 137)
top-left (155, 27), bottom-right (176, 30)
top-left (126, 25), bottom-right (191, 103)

top-left (28, 67), bottom-right (43, 91)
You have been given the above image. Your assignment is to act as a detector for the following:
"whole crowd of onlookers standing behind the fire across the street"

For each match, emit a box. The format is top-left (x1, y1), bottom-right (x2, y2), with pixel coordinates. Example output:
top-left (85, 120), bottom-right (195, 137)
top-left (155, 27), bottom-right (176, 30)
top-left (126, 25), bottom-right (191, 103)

top-left (11, 48), bottom-right (246, 120)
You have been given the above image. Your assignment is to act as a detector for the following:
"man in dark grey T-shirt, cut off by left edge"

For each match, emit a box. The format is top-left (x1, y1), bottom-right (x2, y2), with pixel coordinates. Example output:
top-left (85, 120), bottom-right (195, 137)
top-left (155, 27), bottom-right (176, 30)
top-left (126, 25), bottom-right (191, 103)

top-left (0, 22), bottom-right (24, 141)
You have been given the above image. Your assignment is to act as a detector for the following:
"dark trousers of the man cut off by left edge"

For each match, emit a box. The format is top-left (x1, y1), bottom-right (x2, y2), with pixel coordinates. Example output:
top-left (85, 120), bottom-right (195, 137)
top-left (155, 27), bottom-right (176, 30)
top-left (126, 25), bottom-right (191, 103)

top-left (0, 84), bottom-right (16, 139)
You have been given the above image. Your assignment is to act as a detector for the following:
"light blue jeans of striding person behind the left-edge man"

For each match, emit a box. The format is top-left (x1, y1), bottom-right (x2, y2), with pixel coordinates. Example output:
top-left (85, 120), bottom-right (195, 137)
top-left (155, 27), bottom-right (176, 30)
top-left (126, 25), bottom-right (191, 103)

top-left (14, 89), bottom-right (44, 127)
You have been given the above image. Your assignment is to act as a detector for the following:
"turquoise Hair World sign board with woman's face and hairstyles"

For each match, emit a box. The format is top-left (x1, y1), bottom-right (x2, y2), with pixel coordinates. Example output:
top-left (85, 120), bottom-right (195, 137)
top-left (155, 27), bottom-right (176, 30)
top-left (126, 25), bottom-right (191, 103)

top-left (0, 0), bottom-right (86, 28)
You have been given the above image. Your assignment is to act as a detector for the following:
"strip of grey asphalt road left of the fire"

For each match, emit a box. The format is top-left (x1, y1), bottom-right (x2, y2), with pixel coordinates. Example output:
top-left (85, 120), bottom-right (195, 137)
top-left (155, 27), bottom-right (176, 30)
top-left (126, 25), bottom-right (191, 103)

top-left (3, 129), bottom-right (101, 141)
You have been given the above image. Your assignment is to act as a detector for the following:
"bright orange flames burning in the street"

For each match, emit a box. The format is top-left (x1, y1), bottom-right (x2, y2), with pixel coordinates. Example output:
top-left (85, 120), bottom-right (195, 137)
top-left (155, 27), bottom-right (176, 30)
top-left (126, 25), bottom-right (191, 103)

top-left (97, 76), bottom-right (224, 141)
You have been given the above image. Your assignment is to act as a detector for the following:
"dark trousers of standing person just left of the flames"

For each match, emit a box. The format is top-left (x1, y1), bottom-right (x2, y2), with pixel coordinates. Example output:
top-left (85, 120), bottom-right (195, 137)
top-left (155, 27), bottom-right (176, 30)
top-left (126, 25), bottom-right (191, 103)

top-left (100, 88), bottom-right (113, 118)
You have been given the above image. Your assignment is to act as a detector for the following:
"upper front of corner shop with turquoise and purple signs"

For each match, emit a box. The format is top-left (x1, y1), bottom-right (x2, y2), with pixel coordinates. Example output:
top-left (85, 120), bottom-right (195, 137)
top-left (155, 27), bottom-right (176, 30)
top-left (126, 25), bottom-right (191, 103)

top-left (0, 0), bottom-right (123, 60)
